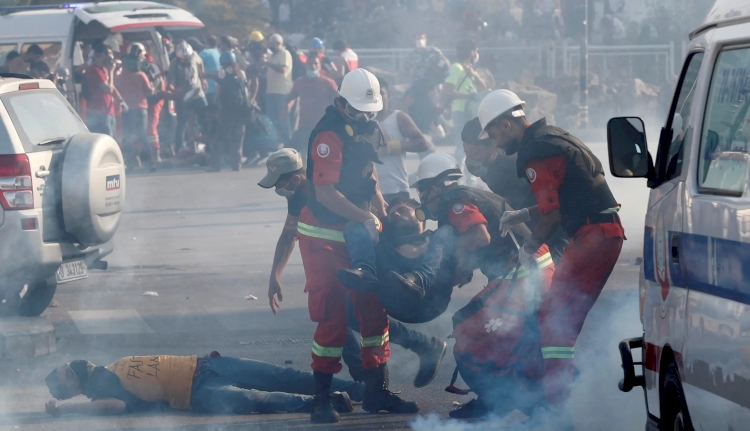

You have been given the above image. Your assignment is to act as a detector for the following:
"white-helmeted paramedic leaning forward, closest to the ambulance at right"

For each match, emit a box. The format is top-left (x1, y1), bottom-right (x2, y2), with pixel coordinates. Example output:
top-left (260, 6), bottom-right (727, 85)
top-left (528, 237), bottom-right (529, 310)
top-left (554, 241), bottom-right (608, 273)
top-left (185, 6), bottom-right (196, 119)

top-left (479, 90), bottom-right (625, 429)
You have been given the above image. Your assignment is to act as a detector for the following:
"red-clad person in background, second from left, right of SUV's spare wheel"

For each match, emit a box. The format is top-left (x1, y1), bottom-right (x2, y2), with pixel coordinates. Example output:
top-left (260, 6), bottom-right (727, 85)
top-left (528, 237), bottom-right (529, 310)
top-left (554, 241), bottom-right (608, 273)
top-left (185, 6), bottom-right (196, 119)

top-left (115, 54), bottom-right (154, 169)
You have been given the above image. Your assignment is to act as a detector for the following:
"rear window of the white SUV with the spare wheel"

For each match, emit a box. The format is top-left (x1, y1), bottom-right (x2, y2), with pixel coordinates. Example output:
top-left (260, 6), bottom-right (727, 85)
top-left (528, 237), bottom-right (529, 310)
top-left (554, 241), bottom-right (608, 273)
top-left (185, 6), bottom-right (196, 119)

top-left (0, 89), bottom-right (87, 152)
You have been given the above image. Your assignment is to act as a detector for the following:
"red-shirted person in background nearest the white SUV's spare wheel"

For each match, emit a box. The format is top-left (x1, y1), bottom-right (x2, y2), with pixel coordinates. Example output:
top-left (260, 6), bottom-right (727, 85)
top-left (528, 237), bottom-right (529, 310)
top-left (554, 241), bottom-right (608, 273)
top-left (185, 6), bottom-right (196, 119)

top-left (85, 44), bottom-right (122, 137)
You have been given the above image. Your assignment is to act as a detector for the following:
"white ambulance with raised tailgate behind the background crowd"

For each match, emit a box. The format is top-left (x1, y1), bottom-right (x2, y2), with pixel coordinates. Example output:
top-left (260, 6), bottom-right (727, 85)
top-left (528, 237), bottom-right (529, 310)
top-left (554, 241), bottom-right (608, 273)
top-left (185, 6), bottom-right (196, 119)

top-left (0, 1), bottom-right (204, 105)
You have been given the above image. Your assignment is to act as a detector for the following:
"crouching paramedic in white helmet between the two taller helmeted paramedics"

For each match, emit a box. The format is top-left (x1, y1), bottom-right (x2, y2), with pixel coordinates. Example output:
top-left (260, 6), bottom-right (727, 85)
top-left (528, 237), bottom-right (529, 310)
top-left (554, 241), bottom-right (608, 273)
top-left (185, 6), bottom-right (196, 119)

top-left (412, 153), bottom-right (555, 419)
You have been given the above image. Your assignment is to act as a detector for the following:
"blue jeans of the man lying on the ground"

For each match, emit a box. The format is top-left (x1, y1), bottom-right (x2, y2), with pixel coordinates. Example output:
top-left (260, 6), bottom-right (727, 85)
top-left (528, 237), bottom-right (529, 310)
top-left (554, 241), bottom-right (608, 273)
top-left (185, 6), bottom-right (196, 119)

top-left (190, 356), bottom-right (364, 414)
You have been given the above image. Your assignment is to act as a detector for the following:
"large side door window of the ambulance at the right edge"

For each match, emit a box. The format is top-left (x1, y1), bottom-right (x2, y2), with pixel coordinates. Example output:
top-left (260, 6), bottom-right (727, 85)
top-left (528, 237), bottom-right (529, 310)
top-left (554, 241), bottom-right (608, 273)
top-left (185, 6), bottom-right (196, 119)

top-left (698, 48), bottom-right (750, 196)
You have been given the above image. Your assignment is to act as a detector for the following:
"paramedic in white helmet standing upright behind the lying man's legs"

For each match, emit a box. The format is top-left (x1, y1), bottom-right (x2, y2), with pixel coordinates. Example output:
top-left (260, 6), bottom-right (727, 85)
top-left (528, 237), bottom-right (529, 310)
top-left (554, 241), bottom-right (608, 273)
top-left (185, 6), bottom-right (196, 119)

top-left (297, 69), bottom-right (419, 423)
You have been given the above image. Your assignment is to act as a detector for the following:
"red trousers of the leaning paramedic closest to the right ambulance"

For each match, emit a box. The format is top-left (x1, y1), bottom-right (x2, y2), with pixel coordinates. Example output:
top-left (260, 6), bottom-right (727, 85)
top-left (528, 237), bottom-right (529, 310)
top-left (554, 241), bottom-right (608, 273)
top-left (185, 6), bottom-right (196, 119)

top-left (539, 223), bottom-right (625, 405)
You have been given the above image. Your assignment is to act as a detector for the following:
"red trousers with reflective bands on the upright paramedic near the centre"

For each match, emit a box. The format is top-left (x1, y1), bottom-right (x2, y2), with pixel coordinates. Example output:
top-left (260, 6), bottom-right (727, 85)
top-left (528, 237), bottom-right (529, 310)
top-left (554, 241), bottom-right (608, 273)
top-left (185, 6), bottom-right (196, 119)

top-left (298, 234), bottom-right (391, 374)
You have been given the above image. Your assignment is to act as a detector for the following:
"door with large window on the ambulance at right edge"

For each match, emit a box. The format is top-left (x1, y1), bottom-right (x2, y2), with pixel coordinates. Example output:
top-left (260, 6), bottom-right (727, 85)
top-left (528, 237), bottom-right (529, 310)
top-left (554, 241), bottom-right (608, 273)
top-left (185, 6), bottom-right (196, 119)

top-left (681, 43), bottom-right (750, 429)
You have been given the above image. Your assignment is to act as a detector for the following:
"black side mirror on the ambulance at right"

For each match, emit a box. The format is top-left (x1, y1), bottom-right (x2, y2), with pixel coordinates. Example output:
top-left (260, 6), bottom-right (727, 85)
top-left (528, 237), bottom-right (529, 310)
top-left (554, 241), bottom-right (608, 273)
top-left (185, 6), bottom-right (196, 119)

top-left (607, 117), bottom-right (653, 178)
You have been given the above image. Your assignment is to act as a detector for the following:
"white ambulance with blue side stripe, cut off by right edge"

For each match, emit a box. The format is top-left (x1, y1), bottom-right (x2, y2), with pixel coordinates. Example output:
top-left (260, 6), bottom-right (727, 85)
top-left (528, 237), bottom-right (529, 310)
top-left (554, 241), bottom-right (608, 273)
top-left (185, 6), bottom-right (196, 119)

top-left (607, 0), bottom-right (750, 430)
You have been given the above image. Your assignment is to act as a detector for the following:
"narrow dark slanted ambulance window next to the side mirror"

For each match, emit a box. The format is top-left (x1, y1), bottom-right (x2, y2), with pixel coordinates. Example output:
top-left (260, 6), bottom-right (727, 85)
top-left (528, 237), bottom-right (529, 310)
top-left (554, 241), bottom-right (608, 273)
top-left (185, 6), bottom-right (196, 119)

top-left (657, 52), bottom-right (703, 181)
